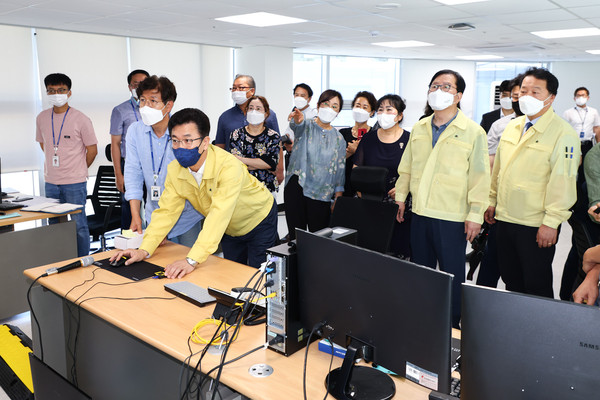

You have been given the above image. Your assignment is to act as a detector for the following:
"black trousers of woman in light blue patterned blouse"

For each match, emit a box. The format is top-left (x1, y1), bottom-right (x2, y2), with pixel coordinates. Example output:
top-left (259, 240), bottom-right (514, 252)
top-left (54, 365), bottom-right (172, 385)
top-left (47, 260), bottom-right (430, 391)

top-left (283, 175), bottom-right (331, 240)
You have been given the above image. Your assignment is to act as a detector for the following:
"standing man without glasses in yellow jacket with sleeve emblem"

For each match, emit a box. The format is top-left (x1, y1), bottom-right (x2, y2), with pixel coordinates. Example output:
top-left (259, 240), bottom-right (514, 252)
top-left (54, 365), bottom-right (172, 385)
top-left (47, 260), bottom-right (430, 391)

top-left (485, 68), bottom-right (581, 298)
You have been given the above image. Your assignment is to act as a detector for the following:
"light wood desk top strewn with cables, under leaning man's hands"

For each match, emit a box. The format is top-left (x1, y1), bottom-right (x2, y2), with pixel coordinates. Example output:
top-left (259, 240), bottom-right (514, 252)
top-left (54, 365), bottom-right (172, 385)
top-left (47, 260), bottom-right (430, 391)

top-left (24, 243), bottom-right (430, 400)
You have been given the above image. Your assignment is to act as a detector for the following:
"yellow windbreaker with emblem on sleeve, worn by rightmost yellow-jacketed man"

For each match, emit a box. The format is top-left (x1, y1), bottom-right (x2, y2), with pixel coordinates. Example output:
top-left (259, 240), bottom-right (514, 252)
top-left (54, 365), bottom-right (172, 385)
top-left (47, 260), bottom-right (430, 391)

top-left (490, 108), bottom-right (581, 229)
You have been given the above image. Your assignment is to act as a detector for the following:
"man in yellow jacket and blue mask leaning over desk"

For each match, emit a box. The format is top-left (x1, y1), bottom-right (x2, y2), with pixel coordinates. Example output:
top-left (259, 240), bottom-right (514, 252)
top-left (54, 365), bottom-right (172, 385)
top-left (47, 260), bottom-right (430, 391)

top-left (112, 108), bottom-right (277, 278)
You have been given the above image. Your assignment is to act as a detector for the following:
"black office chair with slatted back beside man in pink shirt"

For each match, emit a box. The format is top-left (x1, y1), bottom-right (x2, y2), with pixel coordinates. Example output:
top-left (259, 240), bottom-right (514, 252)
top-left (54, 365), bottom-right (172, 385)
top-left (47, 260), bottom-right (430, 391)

top-left (87, 165), bottom-right (121, 253)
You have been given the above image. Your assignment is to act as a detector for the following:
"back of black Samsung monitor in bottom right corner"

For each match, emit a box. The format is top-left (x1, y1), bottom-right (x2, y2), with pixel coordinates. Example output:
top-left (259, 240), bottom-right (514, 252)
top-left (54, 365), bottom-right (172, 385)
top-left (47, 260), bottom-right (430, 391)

top-left (461, 284), bottom-right (600, 400)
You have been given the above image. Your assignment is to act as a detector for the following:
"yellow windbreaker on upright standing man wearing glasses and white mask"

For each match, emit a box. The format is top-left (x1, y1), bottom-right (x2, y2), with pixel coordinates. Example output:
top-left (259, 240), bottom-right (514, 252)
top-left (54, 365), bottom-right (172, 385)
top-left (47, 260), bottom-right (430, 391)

top-left (396, 110), bottom-right (490, 224)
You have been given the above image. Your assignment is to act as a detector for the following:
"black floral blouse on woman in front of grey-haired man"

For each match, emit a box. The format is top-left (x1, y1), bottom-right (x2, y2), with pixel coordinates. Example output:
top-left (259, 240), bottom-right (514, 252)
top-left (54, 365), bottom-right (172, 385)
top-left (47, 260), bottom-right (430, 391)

top-left (229, 126), bottom-right (281, 192)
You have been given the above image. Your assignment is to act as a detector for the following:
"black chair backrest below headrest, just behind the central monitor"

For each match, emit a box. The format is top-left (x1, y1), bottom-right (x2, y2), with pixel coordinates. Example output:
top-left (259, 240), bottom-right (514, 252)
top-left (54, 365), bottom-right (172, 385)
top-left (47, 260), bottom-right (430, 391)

top-left (330, 197), bottom-right (398, 253)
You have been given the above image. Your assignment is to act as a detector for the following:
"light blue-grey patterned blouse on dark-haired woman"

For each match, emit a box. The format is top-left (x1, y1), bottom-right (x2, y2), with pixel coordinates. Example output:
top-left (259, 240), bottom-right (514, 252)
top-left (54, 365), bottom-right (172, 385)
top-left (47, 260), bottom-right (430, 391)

top-left (285, 119), bottom-right (346, 201)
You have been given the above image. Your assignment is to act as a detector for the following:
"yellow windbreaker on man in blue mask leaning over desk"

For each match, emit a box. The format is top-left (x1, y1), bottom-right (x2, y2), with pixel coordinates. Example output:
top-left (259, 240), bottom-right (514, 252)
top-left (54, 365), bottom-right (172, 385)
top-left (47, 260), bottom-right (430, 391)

top-left (140, 145), bottom-right (273, 263)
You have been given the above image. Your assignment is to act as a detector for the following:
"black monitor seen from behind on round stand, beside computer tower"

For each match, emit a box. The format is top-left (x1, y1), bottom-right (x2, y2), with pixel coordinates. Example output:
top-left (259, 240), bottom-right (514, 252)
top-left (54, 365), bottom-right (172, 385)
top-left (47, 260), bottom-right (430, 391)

top-left (296, 230), bottom-right (452, 399)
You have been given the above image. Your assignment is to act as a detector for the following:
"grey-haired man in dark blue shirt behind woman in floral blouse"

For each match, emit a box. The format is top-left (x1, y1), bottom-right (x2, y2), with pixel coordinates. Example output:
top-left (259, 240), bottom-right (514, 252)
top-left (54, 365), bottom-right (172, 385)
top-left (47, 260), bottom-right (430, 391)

top-left (215, 74), bottom-right (279, 151)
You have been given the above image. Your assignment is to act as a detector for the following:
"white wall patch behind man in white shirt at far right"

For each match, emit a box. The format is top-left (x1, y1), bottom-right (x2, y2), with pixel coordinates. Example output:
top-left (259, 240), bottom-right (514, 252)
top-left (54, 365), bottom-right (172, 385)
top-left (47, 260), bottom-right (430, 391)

top-left (552, 62), bottom-right (600, 116)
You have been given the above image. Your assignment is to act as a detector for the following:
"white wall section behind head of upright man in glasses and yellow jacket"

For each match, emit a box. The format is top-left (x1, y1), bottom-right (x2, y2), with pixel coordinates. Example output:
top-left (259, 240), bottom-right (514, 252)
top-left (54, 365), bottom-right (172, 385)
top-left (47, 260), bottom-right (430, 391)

top-left (399, 60), bottom-right (475, 130)
